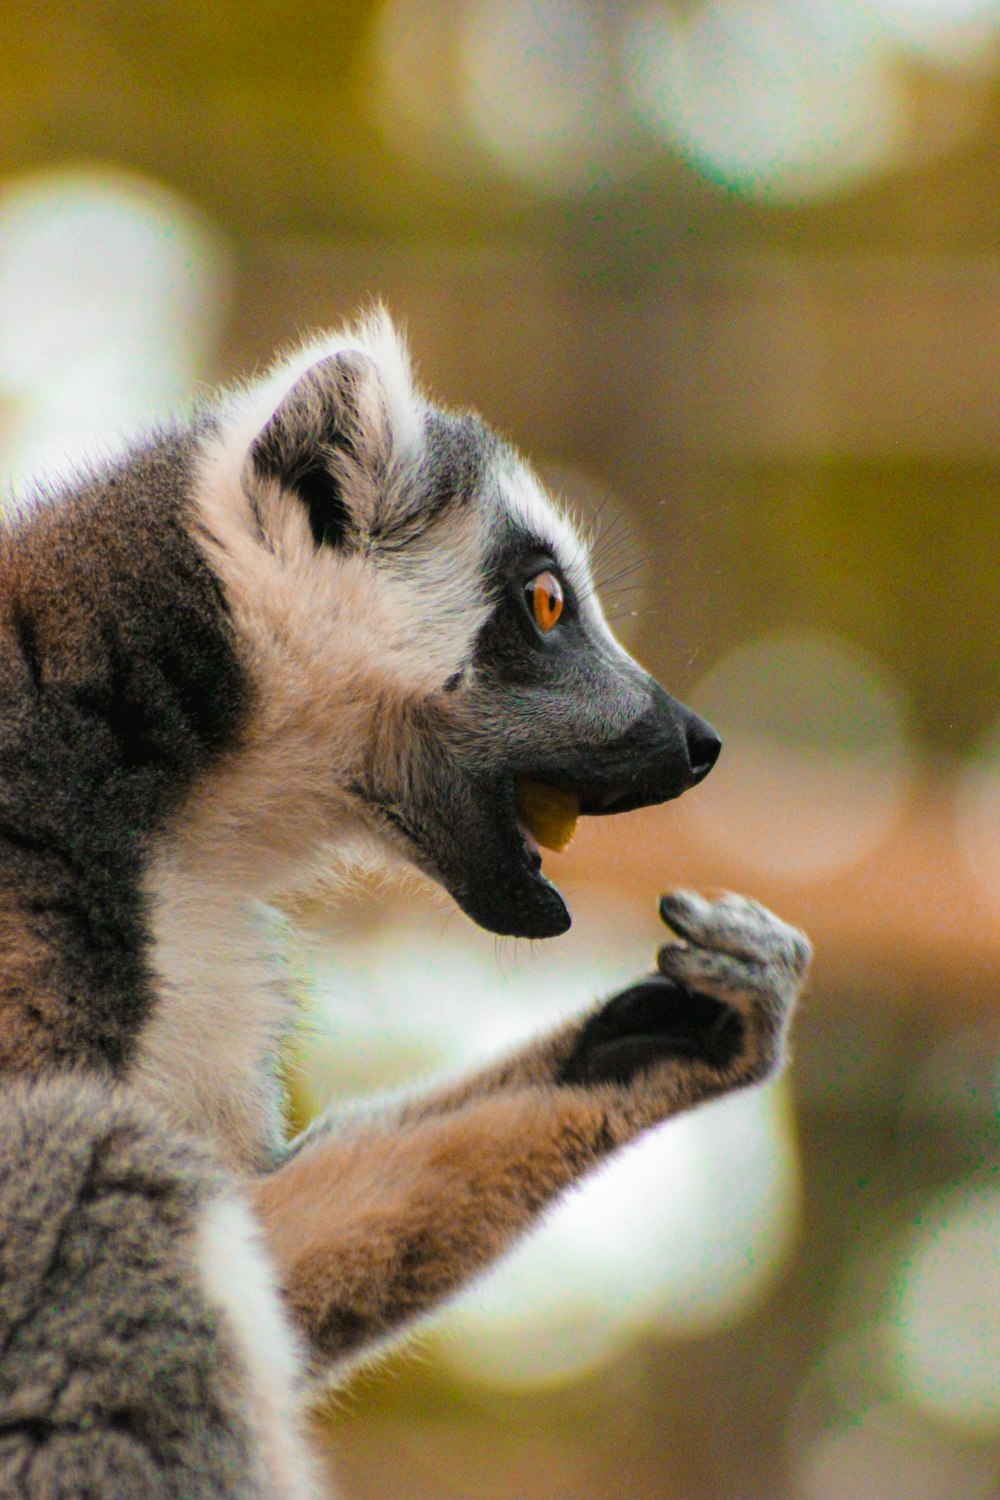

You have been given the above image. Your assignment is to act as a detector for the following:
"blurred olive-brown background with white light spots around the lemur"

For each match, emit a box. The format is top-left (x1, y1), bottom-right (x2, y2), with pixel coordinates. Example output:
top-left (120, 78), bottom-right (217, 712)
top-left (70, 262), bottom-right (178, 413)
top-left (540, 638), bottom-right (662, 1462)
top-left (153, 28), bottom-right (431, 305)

top-left (0, 0), bottom-right (1000, 1500)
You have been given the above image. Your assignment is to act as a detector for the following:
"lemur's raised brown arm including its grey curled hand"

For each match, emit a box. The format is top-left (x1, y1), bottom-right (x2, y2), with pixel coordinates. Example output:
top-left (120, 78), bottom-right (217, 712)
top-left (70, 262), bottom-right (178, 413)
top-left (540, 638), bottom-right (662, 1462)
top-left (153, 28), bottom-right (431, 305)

top-left (253, 897), bottom-right (808, 1362)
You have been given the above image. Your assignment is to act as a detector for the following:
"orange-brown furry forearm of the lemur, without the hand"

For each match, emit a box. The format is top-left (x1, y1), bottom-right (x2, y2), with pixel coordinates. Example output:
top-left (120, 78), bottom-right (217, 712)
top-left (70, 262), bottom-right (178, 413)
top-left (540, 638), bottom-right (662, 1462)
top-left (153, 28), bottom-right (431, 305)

top-left (255, 1089), bottom-right (612, 1362)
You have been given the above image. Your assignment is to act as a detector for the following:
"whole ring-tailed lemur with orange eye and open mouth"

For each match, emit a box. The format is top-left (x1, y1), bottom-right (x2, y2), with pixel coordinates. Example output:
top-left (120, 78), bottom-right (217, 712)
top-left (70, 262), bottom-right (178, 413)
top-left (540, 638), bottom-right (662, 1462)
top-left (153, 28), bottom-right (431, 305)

top-left (0, 315), bottom-right (808, 1500)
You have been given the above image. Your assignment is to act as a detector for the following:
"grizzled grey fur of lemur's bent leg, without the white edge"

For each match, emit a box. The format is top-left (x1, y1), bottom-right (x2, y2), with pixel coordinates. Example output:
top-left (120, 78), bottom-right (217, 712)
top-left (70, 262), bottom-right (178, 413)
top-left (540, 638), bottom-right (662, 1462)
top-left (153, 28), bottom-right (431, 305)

top-left (0, 1076), bottom-right (268, 1500)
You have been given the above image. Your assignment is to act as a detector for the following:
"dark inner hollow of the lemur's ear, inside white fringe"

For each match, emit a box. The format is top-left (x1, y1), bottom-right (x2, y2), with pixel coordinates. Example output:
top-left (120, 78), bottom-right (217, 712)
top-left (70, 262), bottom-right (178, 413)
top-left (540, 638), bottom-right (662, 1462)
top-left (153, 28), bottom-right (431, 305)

top-left (249, 348), bottom-right (393, 546)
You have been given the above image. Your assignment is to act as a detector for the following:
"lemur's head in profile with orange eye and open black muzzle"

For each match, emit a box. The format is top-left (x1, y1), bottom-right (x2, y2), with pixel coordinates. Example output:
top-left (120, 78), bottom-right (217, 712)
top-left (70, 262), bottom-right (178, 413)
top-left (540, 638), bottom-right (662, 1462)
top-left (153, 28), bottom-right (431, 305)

top-left (199, 315), bottom-right (720, 938)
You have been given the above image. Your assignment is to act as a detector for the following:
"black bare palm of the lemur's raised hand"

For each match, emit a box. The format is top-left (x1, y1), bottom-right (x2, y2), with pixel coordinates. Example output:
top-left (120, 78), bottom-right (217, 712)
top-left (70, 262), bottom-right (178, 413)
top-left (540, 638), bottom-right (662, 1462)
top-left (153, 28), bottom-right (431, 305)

top-left (559, 974), bottom-right (744, 1085)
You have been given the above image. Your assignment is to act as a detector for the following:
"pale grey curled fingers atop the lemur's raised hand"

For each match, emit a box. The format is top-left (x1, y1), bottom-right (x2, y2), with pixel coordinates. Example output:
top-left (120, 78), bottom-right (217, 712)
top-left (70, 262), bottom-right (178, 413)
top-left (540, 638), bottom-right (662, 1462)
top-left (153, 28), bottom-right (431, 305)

top-left (658, 891), bottom-right (813, 980)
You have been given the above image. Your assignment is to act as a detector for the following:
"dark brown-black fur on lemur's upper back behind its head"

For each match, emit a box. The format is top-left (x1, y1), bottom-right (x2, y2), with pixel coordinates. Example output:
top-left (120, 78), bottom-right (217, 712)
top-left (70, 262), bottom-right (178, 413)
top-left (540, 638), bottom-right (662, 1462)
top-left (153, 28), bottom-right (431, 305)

top-left (0, 423), bottom-right (249, 1070)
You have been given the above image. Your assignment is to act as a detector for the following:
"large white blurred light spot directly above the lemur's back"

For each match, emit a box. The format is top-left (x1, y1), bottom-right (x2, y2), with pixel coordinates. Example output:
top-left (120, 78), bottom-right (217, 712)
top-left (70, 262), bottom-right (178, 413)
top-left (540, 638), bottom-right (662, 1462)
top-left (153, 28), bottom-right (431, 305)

top-left (0, 167), bottom-right (229, 489)
